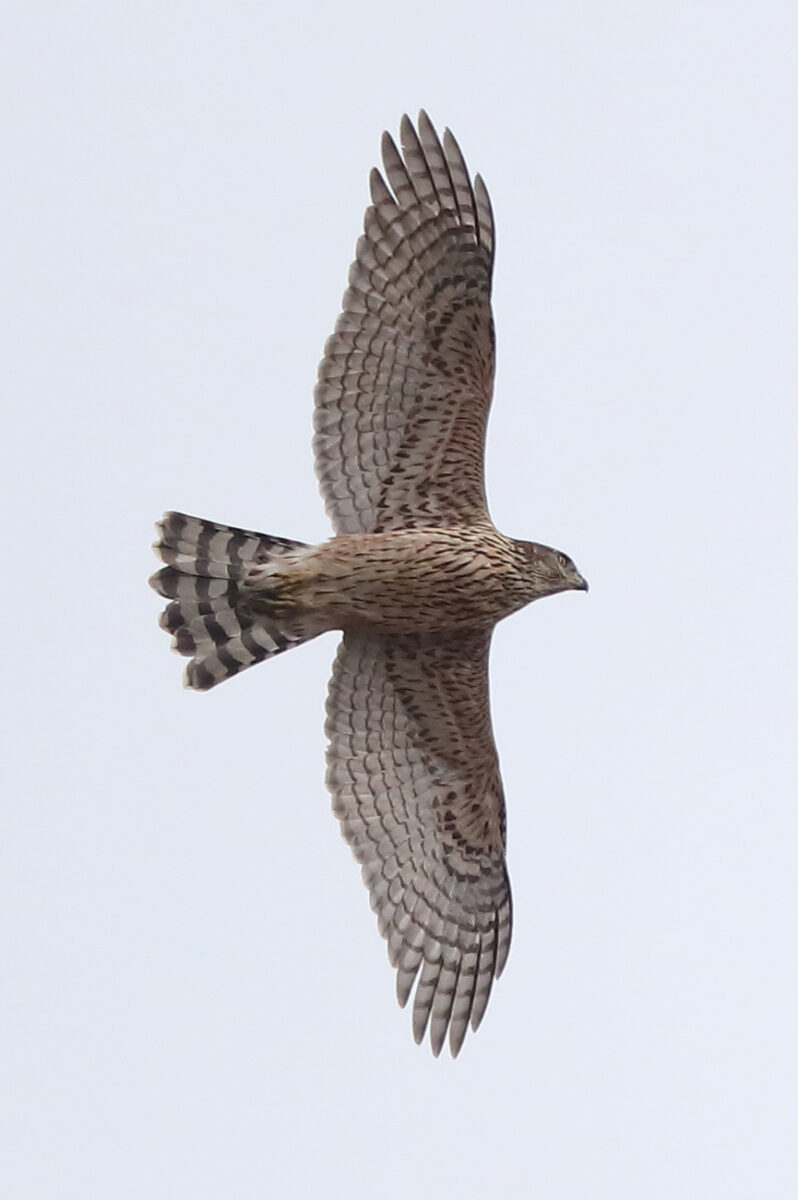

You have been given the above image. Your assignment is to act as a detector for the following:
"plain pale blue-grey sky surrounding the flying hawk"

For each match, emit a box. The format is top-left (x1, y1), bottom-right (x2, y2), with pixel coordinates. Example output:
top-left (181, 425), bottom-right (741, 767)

top-left (0, 0), bottom-right (798, 1200)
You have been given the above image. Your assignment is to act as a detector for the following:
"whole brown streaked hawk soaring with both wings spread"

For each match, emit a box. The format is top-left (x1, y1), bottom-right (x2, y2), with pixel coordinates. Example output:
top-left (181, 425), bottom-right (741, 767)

top-left (151, 112), bottom-right (587, 1055)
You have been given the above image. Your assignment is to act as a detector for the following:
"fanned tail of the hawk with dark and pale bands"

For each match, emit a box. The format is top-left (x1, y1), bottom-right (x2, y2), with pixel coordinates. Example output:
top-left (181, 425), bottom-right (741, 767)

top-left (150, 512), bottom-right (323, 691)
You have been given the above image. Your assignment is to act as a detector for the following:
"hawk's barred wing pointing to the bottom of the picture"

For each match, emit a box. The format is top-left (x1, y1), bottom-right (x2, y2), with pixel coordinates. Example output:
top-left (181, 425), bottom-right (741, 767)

top-left (326, 631), bottom-right (511, 1054)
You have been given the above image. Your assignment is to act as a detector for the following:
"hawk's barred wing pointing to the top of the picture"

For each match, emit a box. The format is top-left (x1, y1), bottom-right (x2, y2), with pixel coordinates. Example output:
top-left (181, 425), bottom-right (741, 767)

top-left (313, 112), bottom-right (493, 533)
